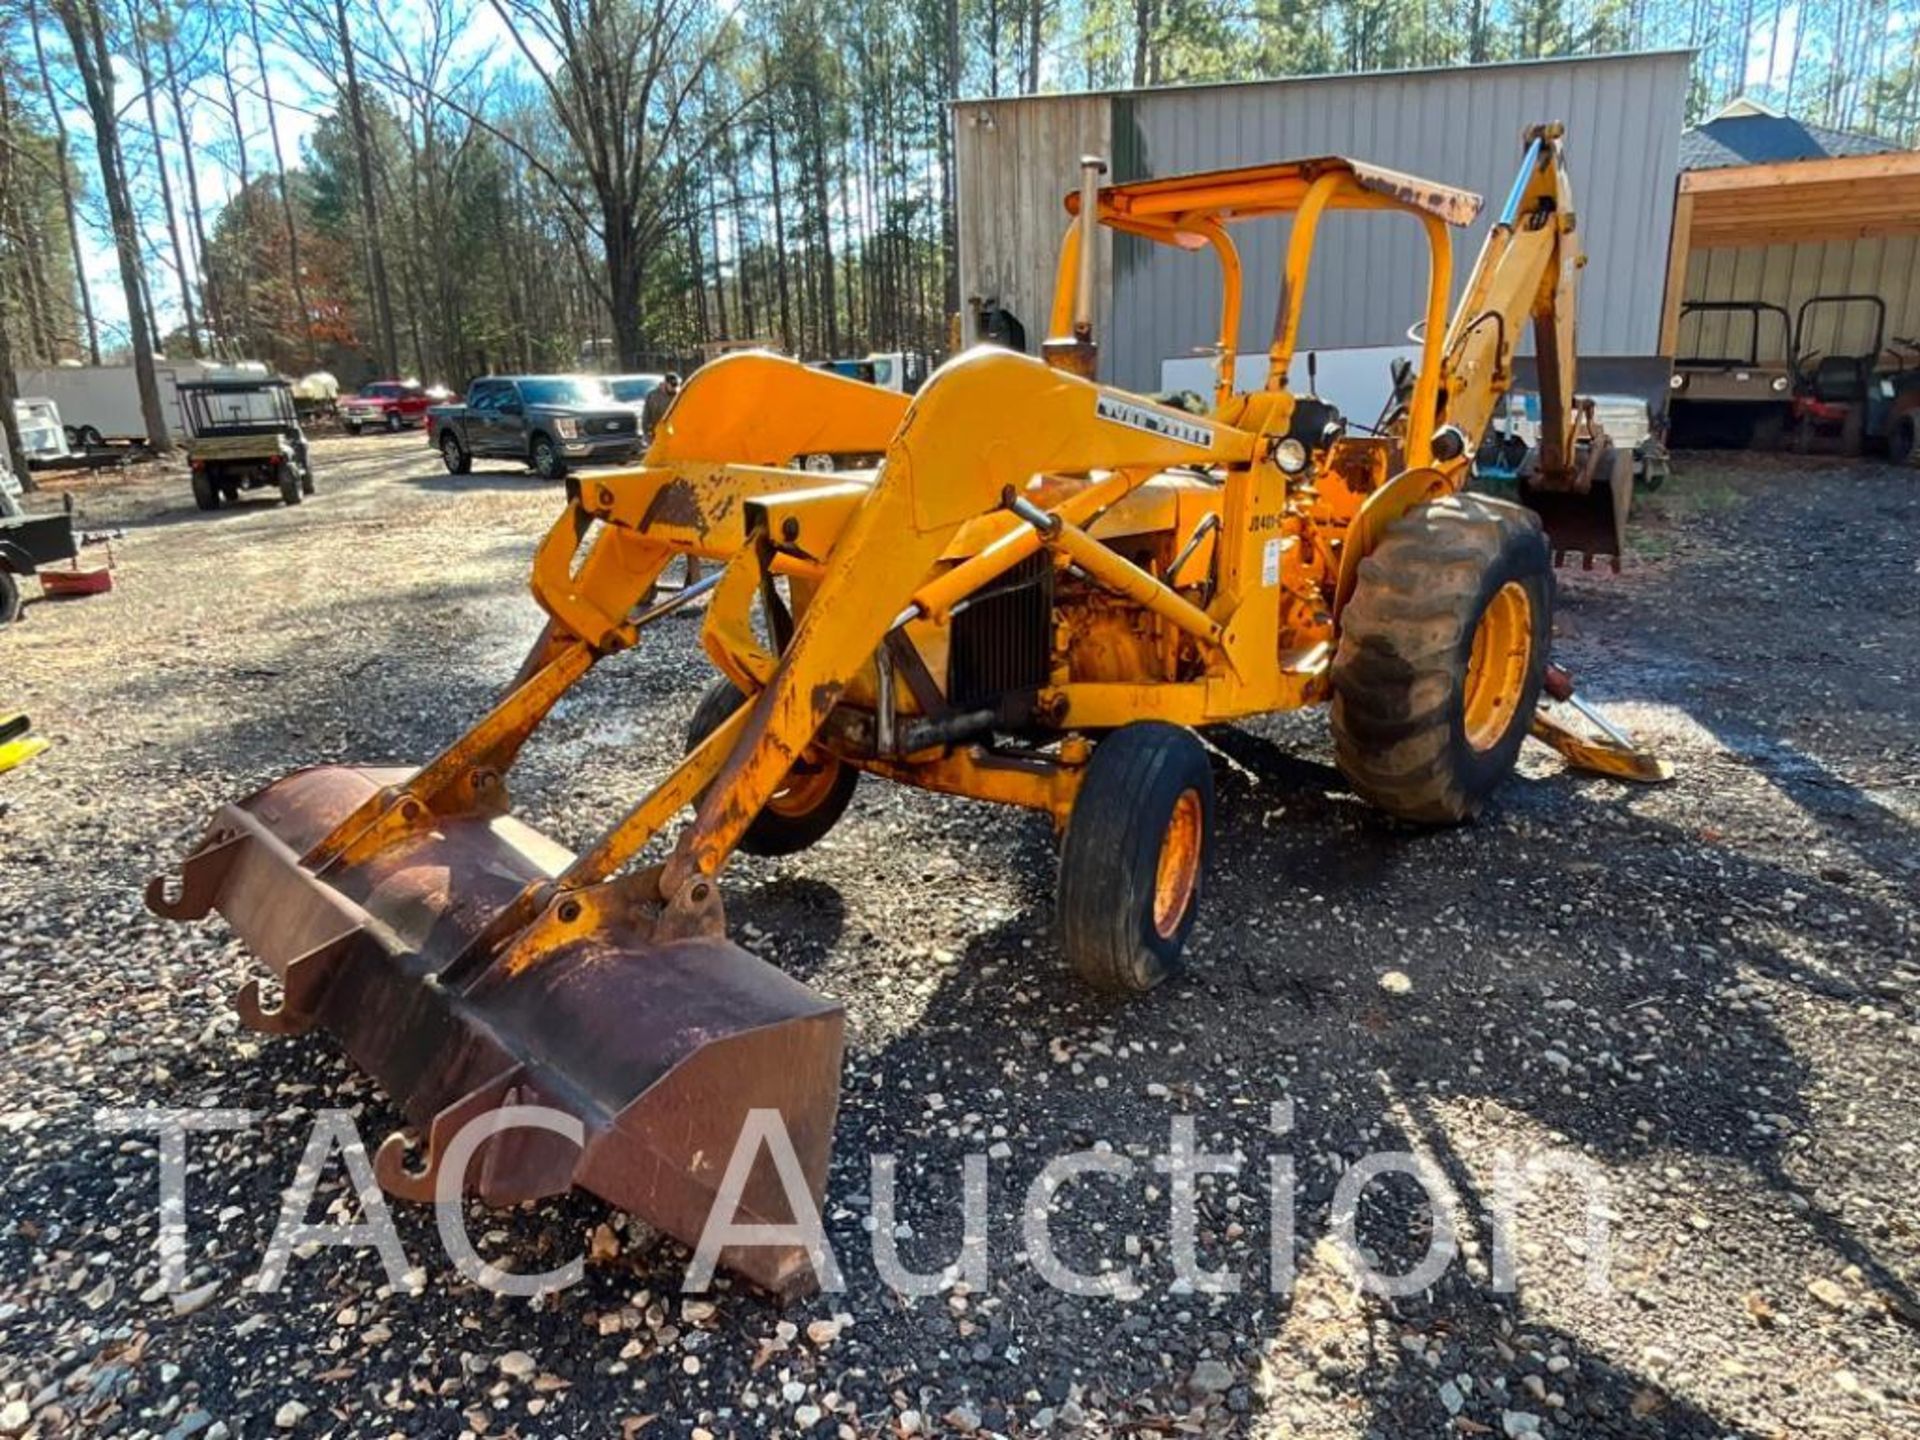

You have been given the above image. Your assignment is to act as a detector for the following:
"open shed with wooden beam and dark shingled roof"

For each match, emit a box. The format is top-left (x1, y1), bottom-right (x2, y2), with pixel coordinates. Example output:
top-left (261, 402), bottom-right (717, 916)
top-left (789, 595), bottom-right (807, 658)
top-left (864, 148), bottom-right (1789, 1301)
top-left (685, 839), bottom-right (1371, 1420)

top-left (1661, 102), bottom-right (1920, 368)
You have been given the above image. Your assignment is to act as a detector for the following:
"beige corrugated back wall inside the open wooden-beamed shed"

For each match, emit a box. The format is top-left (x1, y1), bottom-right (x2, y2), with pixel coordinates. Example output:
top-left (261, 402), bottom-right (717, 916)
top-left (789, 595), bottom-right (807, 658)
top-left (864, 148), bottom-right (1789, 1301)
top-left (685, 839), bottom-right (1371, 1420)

top-left (1678, 234), bottom-right (1920, 359)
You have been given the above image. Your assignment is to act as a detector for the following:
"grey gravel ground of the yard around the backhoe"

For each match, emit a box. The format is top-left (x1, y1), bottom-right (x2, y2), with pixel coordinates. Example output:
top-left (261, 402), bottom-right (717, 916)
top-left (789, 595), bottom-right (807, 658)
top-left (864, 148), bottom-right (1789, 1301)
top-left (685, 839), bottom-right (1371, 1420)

top-left (0, 436), bottom-right (1920, 1440)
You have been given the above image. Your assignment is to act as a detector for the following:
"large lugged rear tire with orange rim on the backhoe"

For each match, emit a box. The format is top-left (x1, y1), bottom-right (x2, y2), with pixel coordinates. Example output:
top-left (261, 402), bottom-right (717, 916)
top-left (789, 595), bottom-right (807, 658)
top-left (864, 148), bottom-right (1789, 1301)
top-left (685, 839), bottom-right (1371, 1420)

top-left (1332, 495), bottom-right (1553, 826)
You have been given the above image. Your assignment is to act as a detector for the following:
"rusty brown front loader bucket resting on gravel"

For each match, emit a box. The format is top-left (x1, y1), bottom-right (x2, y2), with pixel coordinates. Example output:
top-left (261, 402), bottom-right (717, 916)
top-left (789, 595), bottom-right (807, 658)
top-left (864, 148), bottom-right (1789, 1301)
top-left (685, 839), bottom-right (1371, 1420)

top-left (148, 766), bottom-right (843, 1294)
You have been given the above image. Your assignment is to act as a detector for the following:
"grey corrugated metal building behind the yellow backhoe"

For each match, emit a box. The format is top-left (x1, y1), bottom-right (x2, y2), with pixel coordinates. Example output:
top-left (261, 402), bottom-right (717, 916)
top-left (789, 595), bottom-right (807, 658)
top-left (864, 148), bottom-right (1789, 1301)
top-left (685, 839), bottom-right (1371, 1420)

top-left (954, 50), bottom-right (1690, 401)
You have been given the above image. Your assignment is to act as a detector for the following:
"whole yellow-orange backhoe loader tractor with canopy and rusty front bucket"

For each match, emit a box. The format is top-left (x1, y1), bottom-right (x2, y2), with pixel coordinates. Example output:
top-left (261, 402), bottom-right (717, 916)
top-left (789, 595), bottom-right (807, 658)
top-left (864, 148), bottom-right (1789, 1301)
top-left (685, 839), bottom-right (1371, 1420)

top-left (148, 127), bottom-right (1661, 1294)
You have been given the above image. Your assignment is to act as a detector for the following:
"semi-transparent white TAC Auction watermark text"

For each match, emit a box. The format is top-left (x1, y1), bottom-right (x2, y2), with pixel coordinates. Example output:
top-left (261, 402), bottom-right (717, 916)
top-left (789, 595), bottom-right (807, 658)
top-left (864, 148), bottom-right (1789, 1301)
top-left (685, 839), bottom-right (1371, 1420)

top-left (94, 1100), bottom-right (1613, 1300)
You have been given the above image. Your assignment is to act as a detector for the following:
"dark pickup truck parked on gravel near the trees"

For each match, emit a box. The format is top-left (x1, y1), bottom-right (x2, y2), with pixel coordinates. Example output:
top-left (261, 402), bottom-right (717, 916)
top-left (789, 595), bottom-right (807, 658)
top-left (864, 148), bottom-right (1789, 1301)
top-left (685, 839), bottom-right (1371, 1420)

top-left (426, 374), bottom-right (639, 480)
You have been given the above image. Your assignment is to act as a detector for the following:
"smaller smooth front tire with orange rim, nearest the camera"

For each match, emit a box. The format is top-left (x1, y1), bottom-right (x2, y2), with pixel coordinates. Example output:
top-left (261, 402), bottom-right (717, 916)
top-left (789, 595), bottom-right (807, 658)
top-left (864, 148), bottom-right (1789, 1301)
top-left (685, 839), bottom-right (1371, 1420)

top-left (1058, 720), bottom-right (1213, 995)
